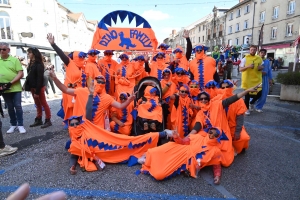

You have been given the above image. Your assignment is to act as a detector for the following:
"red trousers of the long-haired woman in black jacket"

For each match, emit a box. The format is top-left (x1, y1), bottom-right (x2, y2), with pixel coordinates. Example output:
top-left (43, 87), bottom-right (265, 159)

top-left (31, 86), bottom-right (51, 119)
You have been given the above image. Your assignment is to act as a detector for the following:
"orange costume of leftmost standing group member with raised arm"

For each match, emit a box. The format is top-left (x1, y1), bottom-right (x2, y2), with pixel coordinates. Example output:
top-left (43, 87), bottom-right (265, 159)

top-left (62, 51), bottom-right (87, 119)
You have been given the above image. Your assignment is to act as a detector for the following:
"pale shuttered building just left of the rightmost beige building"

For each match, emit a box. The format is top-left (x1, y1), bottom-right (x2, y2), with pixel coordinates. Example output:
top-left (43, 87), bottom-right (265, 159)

top-left (225, 0), bottom-right (257, 48)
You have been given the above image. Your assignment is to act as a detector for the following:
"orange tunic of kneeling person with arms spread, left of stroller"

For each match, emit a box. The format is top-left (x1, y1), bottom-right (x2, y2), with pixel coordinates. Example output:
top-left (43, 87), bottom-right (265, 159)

top-left (73, 88), bottom-right (115, 128)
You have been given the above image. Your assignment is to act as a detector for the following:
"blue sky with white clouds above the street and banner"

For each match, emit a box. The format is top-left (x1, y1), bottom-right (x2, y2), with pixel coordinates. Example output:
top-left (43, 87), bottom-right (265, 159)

top-left (58, 0), bottom-right (239, 42)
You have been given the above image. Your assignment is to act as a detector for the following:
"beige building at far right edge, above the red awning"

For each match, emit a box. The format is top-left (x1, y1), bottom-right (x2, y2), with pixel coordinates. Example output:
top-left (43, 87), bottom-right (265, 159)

top-left (253, 0), bottom-right (300, 66)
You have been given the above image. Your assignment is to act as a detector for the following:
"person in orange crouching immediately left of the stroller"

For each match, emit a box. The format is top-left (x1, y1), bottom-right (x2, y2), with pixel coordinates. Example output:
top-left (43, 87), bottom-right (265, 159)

top-left (110, 93), bottom-right (133, 135)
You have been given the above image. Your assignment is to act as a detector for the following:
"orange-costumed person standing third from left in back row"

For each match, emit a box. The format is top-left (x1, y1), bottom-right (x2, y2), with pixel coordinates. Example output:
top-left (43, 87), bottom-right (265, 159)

top-left (98, 50), bottom-right (118, 96)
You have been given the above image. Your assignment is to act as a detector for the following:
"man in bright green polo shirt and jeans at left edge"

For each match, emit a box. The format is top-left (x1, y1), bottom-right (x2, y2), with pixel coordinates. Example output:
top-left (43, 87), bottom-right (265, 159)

top-left (0, 42), bottom-right (26, 133)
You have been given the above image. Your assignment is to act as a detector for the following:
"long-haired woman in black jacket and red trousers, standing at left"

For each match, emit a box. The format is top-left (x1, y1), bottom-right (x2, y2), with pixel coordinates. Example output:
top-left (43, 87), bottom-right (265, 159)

top-left (26, 47), bottom-right (52, 128)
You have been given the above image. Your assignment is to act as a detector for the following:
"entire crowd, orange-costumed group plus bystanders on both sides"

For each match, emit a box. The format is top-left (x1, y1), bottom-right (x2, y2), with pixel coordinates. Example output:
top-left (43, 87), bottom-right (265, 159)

top-left (0, 31), bottom-right (271, 184)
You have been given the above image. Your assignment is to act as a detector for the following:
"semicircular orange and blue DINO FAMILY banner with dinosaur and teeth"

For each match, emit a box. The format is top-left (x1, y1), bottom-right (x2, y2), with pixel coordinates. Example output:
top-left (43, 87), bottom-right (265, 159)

top-left (92, 10), bottom-right (158, 51)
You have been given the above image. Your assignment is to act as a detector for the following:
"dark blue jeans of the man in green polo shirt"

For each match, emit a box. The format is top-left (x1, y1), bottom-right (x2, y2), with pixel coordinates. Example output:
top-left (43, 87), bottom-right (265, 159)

top-left (2, 92), bottom-right (23, 126)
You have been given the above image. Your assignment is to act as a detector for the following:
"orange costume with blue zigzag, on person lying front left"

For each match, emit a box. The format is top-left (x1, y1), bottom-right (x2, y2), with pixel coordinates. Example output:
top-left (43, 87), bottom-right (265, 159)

top-left (68, 120), bottom-right (159, 171)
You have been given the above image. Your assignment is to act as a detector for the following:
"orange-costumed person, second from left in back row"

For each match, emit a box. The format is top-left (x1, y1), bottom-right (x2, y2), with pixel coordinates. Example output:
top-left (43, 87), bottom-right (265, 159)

top-left (85, 49), bottom-right (101, 80)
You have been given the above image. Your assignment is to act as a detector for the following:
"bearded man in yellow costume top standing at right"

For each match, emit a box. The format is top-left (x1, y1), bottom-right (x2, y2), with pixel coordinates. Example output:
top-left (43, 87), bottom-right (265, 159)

top-left (239, 45), bottom-right (263, 115)
